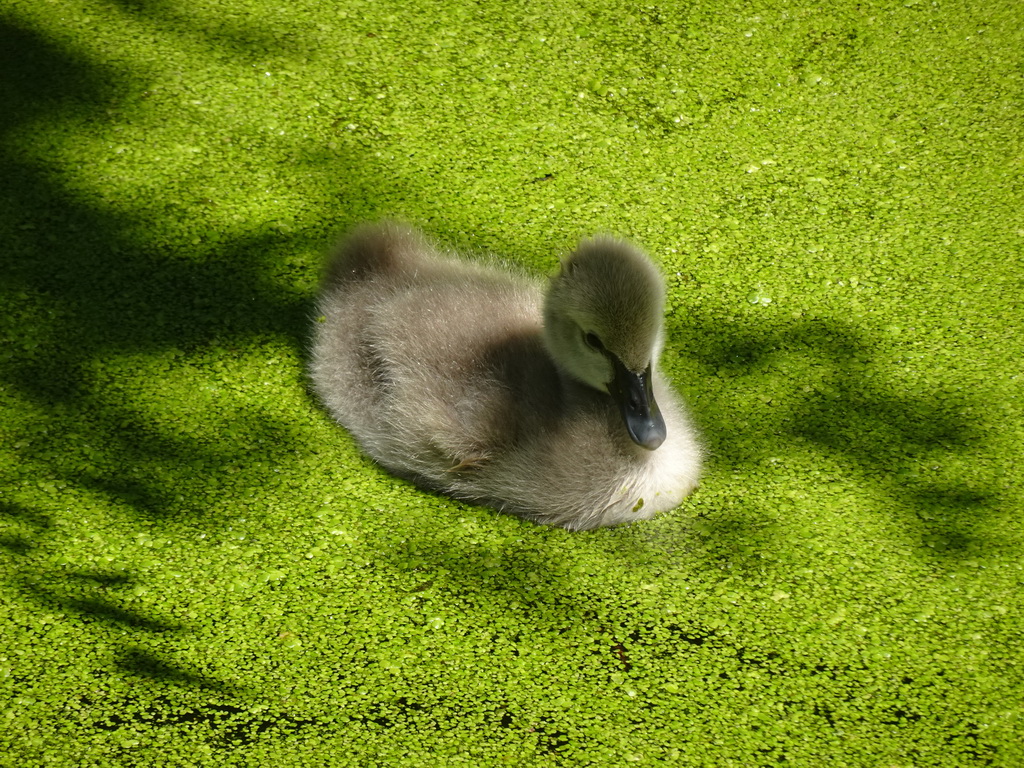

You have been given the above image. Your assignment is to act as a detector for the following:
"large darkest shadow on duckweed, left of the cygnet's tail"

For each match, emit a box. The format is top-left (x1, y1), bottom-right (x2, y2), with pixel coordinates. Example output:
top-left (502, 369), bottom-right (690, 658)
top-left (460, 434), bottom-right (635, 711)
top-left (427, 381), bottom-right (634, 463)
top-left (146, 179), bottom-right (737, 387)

top-left (0, 13), bottom-right (312, 528)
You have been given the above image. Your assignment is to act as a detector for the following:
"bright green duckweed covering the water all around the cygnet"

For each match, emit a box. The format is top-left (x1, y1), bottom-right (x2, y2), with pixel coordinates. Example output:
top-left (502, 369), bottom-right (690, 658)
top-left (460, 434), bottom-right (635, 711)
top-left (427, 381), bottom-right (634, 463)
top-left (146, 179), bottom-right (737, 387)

top-left (0, 0), bottom-right (1024, 766)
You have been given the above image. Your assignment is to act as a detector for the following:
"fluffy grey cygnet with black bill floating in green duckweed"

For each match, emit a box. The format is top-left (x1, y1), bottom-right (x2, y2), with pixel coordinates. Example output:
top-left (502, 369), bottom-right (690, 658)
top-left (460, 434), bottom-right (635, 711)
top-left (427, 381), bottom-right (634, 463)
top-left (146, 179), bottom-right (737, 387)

top-left (311, 223), bottom-right (700, 530)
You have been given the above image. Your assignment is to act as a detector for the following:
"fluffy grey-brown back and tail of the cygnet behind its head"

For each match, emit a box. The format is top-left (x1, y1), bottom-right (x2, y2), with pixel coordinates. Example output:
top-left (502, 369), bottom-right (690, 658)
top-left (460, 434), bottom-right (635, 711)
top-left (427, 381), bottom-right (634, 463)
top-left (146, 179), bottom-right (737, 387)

top-left (312, 225), bottom-right (558, 487)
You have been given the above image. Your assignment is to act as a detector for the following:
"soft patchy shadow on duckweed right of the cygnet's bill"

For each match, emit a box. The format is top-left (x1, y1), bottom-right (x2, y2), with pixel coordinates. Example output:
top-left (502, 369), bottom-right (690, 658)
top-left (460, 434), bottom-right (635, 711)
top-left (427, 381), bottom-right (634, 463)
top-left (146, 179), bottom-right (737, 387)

top-left (677, 319), bottom-right (999, 559)
